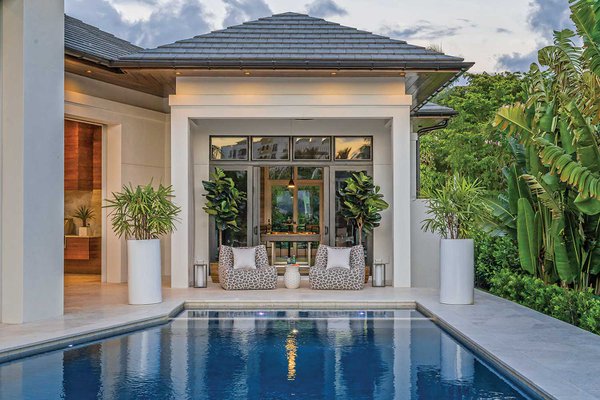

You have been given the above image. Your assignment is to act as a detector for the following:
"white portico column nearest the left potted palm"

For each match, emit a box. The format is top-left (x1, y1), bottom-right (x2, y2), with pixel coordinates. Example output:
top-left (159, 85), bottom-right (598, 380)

top-left (171, 107), bottom-right (194, 288)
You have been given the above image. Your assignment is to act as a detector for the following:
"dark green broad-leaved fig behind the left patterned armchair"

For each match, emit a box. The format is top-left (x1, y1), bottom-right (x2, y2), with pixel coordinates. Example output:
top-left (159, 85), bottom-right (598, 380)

top-left (202, 168), bottom-right (246, 247)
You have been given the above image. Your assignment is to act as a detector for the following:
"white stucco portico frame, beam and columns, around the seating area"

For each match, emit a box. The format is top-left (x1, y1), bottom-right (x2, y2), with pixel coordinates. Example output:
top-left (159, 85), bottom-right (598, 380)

top-left (170, 77), bottom-right (414, 287)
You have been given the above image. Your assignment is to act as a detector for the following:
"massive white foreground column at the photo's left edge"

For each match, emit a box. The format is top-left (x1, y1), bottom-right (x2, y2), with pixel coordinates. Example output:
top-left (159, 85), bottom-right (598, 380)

top-left (1, 0), bottom-right (64, 323)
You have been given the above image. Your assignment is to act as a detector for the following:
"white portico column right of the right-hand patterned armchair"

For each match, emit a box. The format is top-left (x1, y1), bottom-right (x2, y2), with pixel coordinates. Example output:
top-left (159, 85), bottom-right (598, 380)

top-left (392, 106), bottom-right (414, 287)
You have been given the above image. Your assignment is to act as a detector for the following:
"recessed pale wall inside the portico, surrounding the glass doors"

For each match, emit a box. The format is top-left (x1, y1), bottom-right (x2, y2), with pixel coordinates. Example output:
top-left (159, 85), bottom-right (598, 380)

top-left (190, 119), bottom-right (393, 285)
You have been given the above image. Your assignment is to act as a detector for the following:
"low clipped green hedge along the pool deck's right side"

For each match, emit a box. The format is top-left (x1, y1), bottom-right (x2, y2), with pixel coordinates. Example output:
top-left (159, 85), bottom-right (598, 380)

top-left (490, 269), bottom-right (600, 334)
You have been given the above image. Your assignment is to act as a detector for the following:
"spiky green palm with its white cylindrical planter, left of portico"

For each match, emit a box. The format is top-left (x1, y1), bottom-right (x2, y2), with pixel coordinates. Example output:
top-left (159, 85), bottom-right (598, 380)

top-left (105, 182), bottom-right (181, 304)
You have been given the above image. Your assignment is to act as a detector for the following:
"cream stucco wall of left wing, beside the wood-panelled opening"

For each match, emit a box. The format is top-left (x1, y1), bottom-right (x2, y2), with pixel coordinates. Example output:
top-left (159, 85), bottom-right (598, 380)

top-left (65, 74), bottom-right (171, 282)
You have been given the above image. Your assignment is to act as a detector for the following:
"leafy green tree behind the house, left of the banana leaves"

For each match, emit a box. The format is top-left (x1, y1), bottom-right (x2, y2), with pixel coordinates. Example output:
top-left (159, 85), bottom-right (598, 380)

top-left (419, 73), bottom-right (525, 197)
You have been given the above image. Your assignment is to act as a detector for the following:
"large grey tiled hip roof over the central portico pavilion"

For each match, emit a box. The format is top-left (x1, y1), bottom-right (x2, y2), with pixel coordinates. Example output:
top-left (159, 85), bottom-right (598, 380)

top-left (115, 12), bottom-right (472, 69)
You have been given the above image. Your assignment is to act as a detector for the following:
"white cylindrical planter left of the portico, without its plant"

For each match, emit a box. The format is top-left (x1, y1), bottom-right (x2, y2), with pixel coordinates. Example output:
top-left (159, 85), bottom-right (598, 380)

top-left (127, 239), bottom-right (162, 304)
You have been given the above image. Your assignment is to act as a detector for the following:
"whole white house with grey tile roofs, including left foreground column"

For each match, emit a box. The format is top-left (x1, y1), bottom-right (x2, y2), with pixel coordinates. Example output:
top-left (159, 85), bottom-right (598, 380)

top-left (1, 0), bottom-right (472, 323)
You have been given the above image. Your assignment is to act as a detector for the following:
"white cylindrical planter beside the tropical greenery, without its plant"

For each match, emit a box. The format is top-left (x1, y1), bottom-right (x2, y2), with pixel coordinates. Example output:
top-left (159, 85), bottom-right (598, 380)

top-left (440, 239), bottom-right (475, 304)
